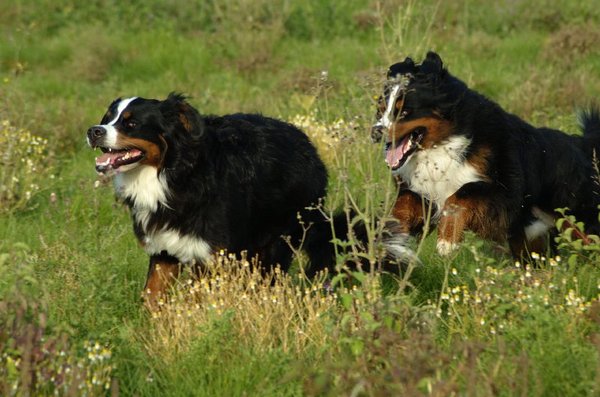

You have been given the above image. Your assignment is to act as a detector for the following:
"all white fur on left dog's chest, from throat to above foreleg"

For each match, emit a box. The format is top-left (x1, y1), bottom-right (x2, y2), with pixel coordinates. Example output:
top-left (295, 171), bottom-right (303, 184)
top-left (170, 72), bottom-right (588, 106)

top-left (114, 166), bottom-right (212, 263)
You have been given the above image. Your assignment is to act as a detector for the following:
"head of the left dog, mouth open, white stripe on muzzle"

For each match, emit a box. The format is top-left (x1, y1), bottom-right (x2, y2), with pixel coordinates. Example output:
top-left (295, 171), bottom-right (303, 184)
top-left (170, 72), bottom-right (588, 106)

top-left (87, 93), bottom-right (203, 175)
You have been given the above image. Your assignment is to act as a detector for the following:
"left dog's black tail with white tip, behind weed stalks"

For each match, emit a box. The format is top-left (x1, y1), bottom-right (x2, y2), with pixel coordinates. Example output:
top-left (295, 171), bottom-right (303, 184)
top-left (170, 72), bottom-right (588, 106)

top-left (303, 212), bottom-right (419, 277)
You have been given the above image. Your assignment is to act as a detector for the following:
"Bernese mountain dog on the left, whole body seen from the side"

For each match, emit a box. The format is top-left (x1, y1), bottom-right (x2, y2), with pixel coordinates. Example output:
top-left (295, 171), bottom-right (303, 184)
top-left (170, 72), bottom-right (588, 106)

top-left (87, 94), bottom-right (404, 301)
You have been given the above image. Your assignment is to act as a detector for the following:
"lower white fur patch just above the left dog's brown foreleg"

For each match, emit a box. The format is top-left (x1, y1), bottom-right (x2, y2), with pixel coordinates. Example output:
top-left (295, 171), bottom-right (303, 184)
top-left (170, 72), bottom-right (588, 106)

top-left (144, 229), bottom-right (212, 263)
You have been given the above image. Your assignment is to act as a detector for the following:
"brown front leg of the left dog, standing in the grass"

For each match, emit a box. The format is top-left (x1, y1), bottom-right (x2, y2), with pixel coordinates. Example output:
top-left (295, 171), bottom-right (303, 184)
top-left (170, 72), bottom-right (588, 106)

top-left (143, 254), bottom-right (181, 308)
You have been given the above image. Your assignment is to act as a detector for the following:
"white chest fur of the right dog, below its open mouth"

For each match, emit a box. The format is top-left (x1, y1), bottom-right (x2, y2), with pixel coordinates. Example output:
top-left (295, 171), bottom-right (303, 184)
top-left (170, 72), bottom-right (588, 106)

top-left (393, 136), bottom-right (485, 212)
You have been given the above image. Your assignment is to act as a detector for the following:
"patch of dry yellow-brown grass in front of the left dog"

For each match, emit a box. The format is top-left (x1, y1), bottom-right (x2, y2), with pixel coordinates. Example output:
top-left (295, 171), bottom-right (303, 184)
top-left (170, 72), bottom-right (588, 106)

top-left (140, 253), bottom-right (337, 362)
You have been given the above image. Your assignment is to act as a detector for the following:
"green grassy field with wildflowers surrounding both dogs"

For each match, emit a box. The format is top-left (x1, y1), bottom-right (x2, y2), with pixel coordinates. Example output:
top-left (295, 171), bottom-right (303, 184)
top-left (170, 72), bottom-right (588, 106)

top-left (0, 0), bottom-right (600, 396)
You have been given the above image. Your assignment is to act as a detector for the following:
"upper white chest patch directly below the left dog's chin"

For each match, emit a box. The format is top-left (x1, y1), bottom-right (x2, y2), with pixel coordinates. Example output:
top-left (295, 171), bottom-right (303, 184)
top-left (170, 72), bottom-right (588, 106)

top-left (114, 165), bottom-right (169, 210)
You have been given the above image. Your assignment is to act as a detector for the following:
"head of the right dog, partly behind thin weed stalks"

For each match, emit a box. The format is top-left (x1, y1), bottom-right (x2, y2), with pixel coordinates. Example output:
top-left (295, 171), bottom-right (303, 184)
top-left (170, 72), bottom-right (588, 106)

top-left (371, 52), bottom-right (466, 170)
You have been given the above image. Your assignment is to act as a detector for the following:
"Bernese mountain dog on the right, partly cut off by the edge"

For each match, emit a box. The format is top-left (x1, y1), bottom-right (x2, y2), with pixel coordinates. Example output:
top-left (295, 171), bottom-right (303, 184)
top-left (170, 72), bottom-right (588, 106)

top-left (371, 52), bottom-right (600, 258)
